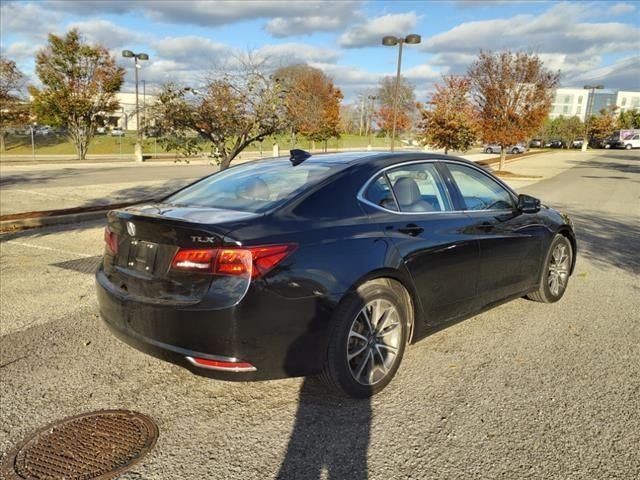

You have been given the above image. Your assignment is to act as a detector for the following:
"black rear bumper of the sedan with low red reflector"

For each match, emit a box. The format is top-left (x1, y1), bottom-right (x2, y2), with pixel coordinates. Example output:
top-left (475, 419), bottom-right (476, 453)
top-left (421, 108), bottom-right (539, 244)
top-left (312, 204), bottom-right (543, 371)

top-left (96, 268), bottom-right (335, 381)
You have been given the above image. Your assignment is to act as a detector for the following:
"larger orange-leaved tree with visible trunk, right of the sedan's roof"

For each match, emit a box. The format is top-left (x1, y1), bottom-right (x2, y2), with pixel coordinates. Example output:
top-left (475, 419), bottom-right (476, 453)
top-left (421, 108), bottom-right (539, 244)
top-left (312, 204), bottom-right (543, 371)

top-left (467, 51), bottom-right (560, 170)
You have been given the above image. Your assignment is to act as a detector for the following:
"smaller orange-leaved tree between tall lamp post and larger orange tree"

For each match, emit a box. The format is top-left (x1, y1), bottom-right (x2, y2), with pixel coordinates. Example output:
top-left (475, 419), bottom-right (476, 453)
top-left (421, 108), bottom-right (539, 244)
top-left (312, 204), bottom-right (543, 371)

top-left (420, 76), bottom-right (478, 154)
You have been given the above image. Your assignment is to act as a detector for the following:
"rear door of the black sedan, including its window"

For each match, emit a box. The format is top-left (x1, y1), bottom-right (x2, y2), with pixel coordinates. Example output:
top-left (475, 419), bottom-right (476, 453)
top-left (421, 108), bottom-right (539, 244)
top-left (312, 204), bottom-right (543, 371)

top-left (361, 161), bottom-right (479, 325)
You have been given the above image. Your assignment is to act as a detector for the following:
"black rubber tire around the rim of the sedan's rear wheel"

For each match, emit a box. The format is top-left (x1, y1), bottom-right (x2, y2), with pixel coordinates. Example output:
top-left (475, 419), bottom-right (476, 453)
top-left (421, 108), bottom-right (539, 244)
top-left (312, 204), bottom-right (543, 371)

top-left (321, 279), bottom-right (411, 398)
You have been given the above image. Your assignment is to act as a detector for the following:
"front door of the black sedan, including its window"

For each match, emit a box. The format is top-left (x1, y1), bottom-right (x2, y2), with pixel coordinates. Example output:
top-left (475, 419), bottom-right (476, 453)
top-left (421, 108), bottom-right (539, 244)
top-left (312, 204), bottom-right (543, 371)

top-left (444, 161), bottom-right (549, 307)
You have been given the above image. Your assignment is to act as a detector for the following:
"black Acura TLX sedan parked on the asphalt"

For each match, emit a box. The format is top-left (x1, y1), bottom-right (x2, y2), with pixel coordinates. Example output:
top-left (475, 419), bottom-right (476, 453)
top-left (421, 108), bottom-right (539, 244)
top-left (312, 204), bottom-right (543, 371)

top-left (96, 151), bottom-right (576, 397)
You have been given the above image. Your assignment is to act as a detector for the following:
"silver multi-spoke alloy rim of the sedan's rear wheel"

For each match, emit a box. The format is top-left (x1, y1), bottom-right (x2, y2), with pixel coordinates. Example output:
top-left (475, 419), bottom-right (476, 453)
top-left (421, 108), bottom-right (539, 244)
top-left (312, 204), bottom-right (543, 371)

top-left (347, 299), bottom-right (403, 386)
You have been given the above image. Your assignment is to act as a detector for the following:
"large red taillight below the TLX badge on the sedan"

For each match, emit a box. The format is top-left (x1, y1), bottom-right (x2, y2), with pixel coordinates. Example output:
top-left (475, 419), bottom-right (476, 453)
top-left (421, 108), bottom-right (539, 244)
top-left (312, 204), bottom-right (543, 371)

top-left (171, 244), bottom-right (296, 278)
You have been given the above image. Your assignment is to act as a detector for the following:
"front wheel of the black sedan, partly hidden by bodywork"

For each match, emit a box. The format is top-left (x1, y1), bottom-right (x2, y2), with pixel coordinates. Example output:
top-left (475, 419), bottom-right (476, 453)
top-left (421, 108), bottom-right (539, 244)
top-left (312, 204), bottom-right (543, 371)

top-left (527, 234), bottom-right (573, 303)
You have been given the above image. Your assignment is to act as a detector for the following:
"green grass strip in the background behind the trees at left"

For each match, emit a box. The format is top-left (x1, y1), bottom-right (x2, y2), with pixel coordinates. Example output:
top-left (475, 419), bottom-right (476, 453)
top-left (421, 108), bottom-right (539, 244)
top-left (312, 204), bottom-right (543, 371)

top-left (5, 132), bottom-right (389, 155)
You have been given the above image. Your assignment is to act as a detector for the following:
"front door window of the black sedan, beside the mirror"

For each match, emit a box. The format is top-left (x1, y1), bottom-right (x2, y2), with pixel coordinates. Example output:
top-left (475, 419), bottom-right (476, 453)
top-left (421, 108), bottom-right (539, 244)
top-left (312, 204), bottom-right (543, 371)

top-left (447, 163), bottom-right (515, 210)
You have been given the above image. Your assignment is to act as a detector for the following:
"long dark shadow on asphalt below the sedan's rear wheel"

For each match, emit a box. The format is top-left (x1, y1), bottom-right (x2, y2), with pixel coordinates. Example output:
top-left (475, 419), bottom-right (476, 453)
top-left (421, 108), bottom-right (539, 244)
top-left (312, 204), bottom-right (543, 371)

top-left (276, 377), bottom-right (371, 480)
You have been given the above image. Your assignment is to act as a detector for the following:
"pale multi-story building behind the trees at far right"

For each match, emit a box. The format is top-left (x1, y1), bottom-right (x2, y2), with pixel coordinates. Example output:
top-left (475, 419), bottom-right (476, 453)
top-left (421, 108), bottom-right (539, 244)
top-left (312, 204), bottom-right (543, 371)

top-left (549, 88), bottom-right (640, 121)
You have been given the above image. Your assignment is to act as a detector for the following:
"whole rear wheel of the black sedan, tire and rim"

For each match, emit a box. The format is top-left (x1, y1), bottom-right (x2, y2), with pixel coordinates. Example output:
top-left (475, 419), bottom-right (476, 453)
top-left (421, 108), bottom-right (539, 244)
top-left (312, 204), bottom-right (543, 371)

top-left (322, 280), bottom-right (409, 398)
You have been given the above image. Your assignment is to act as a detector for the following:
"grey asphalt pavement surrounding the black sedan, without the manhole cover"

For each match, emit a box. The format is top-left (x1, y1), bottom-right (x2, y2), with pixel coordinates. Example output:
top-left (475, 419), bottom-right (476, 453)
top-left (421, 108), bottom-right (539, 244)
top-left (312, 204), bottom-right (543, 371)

top-left (0, 151), bottom-right (640, 480)
